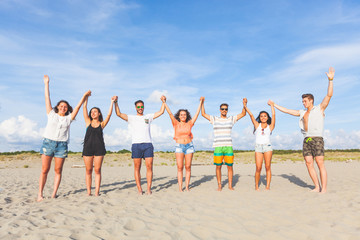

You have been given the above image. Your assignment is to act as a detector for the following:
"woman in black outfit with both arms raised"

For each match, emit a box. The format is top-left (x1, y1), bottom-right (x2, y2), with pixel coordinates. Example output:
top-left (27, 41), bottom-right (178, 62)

top-left (82, 96), bottom-right (117, 196)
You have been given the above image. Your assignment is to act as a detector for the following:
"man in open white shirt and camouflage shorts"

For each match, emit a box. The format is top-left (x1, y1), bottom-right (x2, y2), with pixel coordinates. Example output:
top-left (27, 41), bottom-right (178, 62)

top-left (274, 67), bottom-right (335, 193)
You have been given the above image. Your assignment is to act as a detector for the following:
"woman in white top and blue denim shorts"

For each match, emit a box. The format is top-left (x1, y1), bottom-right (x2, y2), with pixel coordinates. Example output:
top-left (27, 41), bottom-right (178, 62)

top-left (37, 75), bottom-right (91, 202)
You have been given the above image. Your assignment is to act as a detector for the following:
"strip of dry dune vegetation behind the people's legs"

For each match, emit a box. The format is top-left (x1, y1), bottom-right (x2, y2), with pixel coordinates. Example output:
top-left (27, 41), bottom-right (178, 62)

top-left (0, 149), bottom-right (360, 168)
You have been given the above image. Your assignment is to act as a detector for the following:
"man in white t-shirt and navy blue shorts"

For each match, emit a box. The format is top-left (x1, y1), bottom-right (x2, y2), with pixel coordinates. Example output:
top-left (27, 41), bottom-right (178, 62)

top-left (115, 96), bottom-right (165, 194)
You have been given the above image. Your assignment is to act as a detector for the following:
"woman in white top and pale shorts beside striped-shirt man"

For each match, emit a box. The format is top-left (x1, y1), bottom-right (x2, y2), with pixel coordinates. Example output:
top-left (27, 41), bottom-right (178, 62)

top-left (243, 98), bottom-right (275, 191)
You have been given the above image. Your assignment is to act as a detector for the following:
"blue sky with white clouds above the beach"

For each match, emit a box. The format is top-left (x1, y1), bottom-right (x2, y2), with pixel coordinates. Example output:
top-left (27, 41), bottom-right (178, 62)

top-left (0, 0), bottom-right (360, 151)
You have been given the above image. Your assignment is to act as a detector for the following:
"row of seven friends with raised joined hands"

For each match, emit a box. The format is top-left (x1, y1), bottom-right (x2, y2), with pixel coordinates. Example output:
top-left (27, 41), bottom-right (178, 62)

top-left (37, 67), bottom-right (335, 201)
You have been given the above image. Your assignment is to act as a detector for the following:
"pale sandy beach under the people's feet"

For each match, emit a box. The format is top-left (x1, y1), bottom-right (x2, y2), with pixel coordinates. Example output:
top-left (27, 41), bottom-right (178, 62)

top-left (0, 152), bottom-right (360, 240)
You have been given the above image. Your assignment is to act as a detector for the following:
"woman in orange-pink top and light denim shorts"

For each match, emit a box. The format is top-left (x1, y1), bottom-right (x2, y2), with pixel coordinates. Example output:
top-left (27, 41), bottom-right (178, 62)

top-left (161, 96), bottom-right (204, 192)
